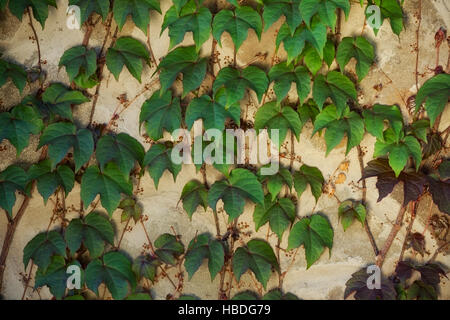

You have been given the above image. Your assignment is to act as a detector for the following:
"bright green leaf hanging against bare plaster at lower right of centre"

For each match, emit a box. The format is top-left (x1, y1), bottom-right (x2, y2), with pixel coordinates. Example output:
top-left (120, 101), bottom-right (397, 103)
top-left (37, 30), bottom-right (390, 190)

top-left (287, 214), bottom-right (333, 269)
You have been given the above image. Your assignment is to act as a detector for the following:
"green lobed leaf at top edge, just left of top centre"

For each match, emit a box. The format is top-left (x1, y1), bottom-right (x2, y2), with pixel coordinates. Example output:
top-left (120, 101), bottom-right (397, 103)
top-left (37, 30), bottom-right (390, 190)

top-left (161, 0), bottom-right (212, 51)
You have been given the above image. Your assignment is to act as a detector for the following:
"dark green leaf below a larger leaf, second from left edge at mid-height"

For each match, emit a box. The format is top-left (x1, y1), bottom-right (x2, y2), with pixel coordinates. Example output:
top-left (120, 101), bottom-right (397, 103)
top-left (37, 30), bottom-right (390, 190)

top-left (28, 159), bottom-right (75, 203)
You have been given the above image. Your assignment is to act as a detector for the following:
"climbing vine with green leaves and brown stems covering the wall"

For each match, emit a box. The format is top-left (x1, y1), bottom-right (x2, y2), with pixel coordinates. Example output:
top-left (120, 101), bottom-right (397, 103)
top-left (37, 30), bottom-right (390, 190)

top-left (0, 0), bottom-right (450, 299)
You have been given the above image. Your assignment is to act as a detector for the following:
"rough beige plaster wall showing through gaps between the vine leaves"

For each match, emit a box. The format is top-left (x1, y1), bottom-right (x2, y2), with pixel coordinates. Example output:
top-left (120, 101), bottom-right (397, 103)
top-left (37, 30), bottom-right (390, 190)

top-left (0, 0), bottom-right (450, 299)
